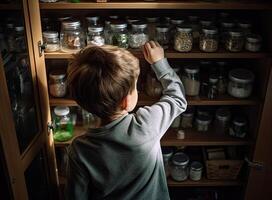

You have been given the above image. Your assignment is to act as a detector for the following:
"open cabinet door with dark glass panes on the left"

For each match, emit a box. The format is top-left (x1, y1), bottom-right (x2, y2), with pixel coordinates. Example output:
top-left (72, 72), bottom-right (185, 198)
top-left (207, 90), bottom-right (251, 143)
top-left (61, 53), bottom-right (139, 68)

top-left (0, 0), bottom-right (57, 200)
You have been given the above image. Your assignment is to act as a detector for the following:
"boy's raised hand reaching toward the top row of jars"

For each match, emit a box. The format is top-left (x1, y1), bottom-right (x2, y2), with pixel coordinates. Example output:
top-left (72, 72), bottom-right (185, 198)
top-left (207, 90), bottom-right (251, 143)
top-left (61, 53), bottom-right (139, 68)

top-left (143, 41), bottom-right (164, 64)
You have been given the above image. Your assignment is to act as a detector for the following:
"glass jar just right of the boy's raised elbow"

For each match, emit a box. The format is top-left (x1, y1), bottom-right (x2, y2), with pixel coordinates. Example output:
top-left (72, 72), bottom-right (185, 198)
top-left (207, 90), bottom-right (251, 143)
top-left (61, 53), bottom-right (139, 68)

top-left (181, 66), bottom-right (200, 96)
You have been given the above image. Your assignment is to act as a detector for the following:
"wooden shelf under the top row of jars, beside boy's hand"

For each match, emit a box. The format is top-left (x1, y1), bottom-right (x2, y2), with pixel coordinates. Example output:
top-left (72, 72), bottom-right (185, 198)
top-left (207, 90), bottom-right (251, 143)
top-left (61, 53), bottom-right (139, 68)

top-left (45, 49), bottom-right (269, 59)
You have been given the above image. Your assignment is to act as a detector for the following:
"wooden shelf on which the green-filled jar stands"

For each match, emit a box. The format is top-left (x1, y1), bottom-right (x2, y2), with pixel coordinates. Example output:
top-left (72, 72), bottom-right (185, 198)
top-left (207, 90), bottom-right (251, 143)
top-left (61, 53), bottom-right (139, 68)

top-left (55, 126), bottom-right (254, 147)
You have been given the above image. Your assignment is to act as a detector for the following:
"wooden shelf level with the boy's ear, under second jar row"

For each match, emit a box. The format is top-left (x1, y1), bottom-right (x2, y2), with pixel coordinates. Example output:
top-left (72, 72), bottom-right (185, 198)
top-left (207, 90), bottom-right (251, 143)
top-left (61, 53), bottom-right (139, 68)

top-left (50, 94), bottom-right (259, 106)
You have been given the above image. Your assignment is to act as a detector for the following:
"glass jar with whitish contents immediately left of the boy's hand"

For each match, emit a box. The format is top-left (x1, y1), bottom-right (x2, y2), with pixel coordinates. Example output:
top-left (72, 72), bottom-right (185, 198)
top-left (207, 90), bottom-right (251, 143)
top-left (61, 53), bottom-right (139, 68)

top-left (128, 22), bottom-right (149, 49)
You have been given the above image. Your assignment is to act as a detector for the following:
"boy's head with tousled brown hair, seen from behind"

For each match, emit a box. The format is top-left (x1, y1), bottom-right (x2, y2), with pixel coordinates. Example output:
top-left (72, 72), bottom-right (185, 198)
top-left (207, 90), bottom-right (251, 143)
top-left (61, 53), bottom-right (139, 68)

top-left (67, 45), bottom-right (140, 120)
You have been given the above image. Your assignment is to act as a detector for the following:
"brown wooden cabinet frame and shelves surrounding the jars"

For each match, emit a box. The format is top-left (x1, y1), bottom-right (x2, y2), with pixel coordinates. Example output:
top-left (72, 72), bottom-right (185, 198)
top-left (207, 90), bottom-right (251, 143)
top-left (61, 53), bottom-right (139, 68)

top-left (0, 0), bottom-right (272, 199)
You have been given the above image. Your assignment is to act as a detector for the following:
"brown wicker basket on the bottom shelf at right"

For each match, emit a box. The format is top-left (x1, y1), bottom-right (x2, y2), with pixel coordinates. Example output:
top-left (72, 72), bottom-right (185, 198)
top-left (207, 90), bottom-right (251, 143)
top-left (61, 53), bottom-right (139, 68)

top-left (203, 149), bottom-right (244, 180)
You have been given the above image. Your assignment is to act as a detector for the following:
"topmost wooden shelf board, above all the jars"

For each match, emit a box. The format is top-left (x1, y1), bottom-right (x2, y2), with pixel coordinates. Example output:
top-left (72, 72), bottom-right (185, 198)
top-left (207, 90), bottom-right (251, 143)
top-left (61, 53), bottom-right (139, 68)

top-left (40, 0), bottom-right (272, 10)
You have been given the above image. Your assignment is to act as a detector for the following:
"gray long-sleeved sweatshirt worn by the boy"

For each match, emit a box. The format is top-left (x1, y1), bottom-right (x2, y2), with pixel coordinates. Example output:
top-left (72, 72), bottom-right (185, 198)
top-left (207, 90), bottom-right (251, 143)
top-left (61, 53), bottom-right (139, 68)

top-left (65, 59), bottom-right (187, 200)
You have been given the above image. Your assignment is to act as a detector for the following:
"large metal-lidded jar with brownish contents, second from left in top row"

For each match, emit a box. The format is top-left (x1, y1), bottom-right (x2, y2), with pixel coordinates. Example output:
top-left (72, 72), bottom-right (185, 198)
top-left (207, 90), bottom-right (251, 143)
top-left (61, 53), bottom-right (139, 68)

top-left (60, 20), bottom-right (85, 53)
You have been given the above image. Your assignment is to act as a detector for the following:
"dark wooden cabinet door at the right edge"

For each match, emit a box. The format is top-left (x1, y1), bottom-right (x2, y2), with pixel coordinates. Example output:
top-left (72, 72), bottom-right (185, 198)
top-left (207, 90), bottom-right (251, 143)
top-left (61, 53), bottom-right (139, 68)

top-left (245, 66), bottom-right (272, 200)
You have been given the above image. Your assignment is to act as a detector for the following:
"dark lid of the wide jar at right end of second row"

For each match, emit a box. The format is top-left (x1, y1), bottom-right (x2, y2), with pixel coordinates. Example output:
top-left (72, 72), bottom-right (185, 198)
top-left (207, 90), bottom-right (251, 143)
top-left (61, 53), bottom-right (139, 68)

top-left (229, 68), bottom-right (254, 83)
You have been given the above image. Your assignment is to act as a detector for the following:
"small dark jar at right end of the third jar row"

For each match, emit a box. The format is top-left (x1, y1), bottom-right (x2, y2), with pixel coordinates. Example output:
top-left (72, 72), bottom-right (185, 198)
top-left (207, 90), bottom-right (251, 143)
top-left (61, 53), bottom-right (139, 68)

top-left (229, 116), bottom-right (248, 138)
